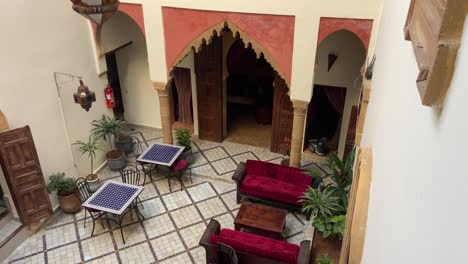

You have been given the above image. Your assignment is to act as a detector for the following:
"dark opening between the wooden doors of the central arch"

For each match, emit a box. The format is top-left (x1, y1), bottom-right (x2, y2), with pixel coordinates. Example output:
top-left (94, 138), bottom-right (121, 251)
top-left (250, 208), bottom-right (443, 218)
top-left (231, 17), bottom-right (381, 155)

top-left (223, 38), bottom-right (275, 148)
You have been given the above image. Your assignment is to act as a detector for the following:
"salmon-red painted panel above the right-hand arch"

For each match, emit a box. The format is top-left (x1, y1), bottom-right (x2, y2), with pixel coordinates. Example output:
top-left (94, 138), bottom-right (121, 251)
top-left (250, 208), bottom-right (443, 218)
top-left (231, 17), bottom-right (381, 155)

top-left (317, 17), bottom-right (373, 50)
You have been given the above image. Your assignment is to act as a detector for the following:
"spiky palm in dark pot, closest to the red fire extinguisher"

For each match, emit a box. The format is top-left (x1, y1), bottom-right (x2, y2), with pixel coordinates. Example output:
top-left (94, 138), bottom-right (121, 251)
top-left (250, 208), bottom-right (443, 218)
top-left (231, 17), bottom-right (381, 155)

top-left (91, 115), bottom-right (127, 171)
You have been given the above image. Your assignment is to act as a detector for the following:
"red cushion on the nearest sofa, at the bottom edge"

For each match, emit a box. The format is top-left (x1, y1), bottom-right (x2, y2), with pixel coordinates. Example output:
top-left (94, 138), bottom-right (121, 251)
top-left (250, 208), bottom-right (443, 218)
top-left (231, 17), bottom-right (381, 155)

top-left (210, 229), bottom-right (299, 264)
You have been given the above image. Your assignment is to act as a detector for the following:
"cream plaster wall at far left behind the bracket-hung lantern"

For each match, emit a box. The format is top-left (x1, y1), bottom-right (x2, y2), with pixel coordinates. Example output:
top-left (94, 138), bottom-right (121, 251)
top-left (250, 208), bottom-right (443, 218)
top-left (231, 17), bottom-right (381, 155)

top-left (0, 0), bottom-right (109, 212)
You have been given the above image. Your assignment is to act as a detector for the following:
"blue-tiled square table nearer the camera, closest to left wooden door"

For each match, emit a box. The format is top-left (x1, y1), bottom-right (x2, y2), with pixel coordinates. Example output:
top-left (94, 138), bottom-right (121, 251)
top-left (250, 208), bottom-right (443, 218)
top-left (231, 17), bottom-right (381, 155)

top-left (83, 181), bottom-right (145, 244)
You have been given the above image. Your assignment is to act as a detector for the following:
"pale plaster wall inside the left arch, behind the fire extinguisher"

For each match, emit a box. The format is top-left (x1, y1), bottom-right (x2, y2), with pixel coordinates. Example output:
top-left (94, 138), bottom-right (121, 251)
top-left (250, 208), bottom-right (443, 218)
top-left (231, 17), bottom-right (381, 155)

top-left (102, 12), bottom-right (161, 128)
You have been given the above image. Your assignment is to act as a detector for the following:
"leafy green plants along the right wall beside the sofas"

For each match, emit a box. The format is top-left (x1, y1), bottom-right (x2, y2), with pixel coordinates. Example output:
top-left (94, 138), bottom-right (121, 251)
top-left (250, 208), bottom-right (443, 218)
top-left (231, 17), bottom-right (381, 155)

top-left (300, 147), bottom-right (355, 263)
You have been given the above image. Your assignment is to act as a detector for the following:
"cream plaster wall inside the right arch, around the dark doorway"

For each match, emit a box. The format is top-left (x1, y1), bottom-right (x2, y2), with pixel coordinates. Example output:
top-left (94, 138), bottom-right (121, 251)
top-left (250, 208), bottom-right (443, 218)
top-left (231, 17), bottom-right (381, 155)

top-left (314, 30), bottom-right (366, 157)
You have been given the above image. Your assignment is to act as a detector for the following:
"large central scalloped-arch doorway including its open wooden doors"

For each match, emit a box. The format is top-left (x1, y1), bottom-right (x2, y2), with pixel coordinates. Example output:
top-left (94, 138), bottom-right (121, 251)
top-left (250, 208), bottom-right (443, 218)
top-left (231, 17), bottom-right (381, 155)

top-left (176, 23), bottom-right (293, 153)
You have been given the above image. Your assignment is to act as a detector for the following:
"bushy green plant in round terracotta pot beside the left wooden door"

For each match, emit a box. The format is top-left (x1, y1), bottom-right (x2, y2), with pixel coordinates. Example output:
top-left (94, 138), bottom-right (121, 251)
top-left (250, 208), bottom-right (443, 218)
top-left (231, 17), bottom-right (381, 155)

top-left (47, 172), bottom-right (81, 214)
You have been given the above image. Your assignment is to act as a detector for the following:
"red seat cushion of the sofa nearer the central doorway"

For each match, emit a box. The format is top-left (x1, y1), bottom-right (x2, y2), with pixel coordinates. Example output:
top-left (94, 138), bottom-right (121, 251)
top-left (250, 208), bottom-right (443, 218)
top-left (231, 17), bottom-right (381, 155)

top-left (240, 174), bottom-right (307, 205)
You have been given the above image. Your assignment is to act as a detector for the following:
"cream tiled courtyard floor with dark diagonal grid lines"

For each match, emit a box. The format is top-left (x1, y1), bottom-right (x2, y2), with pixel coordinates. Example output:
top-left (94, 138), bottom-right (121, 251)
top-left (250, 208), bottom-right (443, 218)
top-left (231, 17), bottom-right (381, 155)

top-left (7, 129), bottom-right (326, 264)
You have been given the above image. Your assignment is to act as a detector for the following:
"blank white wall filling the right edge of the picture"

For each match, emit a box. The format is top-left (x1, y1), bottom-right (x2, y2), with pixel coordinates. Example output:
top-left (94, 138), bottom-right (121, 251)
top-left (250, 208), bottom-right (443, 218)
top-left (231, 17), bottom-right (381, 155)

top-left (363, 0), bottom-right (468, 264)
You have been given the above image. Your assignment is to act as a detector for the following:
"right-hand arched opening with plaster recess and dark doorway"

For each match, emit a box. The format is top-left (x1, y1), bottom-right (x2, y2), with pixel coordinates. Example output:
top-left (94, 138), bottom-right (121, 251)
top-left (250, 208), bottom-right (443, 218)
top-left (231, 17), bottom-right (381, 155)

top-left (304, 30), bottom-right (366, 158)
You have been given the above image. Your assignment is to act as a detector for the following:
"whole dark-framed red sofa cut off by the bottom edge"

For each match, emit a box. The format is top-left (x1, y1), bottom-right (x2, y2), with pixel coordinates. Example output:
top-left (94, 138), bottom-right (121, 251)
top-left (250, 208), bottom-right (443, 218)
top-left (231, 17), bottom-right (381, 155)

top-left (199, 219), bottom-right (310, 264)
